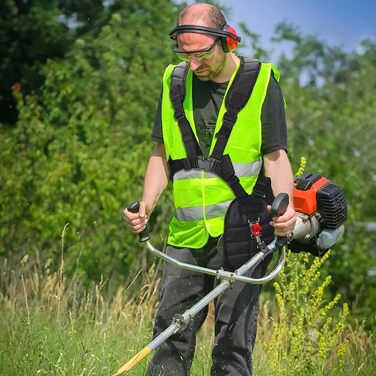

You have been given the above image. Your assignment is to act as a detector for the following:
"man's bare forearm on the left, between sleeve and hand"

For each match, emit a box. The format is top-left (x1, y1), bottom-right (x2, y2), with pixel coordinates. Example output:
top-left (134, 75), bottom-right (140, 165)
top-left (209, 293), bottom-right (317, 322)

top-left (142, 144), bottom-right (168, 216)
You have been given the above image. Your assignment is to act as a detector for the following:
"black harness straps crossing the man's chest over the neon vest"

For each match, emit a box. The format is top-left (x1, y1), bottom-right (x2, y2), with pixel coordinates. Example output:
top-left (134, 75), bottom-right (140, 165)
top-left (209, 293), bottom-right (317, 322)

top-left (169, 57), bottom-right (263, 214)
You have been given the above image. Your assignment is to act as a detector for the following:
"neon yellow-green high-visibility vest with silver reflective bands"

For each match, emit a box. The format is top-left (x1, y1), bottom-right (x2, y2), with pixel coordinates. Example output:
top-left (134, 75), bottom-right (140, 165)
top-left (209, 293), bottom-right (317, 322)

top-left (162, 63), bottom-right (279, 248)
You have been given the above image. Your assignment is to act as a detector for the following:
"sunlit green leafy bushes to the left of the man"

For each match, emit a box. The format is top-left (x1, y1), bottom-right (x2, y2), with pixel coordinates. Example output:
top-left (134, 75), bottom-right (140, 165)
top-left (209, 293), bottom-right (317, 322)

top-left (0, 0), bottom-right (175, 280)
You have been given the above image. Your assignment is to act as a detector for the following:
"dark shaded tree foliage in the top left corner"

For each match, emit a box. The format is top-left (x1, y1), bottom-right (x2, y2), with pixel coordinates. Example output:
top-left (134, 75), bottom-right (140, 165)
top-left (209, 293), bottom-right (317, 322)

top-left (0, 0), bottom-right (113, 124)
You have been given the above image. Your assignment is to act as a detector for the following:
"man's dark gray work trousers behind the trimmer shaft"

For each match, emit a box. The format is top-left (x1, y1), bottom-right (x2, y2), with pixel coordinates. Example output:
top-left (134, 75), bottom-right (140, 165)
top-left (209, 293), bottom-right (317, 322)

top-left (147, 239), bottom-right (267, 376)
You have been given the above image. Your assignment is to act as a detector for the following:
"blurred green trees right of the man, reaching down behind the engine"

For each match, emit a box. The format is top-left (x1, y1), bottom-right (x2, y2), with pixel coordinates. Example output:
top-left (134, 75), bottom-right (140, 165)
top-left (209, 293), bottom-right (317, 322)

top-left (276, 24), bottom-right (376, 328)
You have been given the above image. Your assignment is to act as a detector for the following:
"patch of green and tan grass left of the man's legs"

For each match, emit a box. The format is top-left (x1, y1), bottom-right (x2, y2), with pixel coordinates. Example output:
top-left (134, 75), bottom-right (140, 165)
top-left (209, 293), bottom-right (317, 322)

top-left (0, 254), bottom-right (156, 376)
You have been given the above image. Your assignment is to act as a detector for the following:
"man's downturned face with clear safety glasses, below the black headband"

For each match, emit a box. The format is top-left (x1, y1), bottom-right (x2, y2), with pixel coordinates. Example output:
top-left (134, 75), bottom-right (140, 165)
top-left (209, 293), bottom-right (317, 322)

top-left (177, 33), bottom-right (226, 81)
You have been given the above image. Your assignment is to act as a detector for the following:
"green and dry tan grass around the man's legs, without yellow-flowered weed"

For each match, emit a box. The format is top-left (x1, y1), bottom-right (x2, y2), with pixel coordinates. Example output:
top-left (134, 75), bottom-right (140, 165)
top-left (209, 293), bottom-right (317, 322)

top-left (0, 253), bottom-right (376, 376)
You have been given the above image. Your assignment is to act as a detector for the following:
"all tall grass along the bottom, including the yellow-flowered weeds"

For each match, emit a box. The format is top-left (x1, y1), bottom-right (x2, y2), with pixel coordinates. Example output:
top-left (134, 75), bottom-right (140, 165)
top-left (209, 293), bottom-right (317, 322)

top-left (0, 245), bottom-right (376, 376)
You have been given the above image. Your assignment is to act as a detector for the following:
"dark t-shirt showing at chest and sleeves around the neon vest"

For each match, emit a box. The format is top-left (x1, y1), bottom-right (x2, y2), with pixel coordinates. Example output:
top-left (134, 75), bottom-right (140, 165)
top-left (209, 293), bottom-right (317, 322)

top-left (151, 75), bottom-right (287, 156)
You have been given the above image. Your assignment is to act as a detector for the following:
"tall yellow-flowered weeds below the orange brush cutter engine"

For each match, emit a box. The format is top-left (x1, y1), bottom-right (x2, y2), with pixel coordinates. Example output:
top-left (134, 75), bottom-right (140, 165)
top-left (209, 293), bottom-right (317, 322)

top-left (256, 252), bottom-right (376, 376)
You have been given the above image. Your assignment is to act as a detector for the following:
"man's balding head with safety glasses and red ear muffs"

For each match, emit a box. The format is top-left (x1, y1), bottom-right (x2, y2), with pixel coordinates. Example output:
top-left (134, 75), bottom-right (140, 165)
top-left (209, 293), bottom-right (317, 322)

top-left (170, 3), bottom-right (240, 81)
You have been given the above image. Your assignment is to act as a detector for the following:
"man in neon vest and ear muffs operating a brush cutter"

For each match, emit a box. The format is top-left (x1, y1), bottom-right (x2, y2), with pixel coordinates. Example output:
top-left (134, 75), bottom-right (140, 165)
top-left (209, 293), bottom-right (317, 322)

top-left (124, 3), bottom-right (296, 376)
